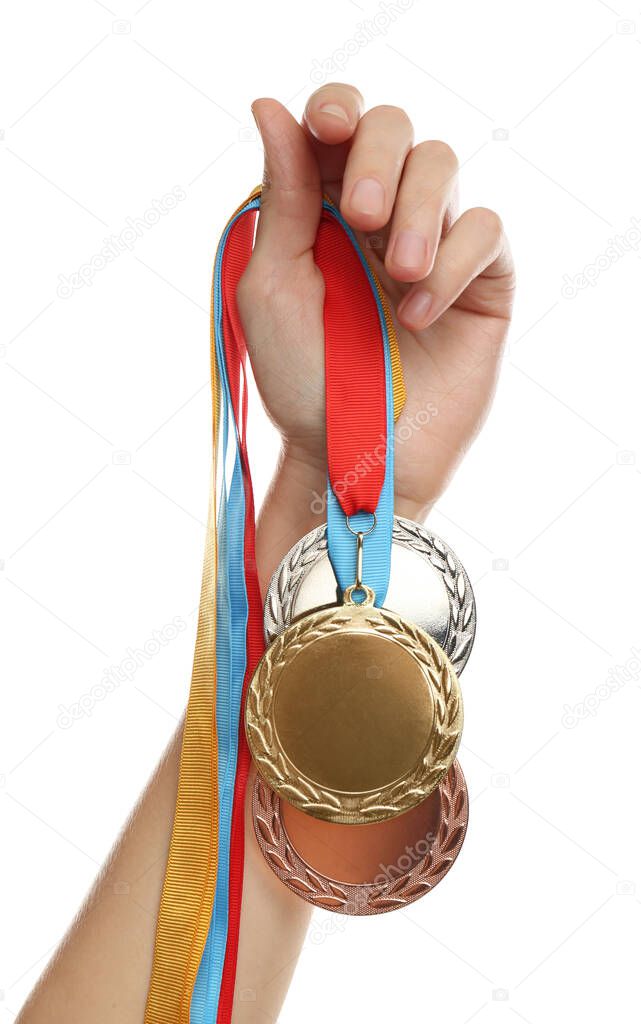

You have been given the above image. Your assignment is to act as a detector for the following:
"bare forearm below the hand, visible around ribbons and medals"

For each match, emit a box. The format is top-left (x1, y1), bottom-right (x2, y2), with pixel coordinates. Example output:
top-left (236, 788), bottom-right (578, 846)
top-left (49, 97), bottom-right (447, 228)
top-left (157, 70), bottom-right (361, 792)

top-left (18, 455), bottom-right (325, 1024)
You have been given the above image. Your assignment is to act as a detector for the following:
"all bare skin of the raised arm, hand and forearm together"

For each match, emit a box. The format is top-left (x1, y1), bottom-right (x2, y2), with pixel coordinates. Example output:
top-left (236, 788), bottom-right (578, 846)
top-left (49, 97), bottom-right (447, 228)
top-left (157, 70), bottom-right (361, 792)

top-left (17, 85), bottom-right (514, 1024)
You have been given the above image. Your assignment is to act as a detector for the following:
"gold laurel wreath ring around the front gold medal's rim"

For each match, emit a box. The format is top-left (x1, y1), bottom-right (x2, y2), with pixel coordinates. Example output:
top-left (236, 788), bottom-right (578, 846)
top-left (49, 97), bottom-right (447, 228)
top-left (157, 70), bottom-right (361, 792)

top-left (246, 608), bottom-right (463, 823)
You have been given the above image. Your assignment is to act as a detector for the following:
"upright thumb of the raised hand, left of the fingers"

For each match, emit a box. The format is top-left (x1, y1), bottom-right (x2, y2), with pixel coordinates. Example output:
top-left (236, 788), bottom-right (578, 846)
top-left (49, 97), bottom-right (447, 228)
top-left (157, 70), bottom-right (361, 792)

top-left (252, 99), bottom-right (323, 262)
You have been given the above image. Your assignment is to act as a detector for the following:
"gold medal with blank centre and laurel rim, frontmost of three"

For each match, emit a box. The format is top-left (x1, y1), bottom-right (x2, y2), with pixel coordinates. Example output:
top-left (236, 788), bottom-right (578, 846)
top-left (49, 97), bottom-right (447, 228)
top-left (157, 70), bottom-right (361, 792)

top-left (246, 579), bottom-right (463, 824)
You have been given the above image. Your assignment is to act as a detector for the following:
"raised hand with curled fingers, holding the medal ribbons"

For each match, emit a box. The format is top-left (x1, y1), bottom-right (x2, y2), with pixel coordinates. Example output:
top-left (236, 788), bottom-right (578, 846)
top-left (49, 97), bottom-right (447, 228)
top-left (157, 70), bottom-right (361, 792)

top-left (239, 84), bottom-right (514, 518)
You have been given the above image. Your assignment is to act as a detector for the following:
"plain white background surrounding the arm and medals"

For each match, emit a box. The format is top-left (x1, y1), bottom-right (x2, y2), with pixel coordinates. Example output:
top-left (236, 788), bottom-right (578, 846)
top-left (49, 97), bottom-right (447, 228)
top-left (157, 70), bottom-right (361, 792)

top-left (0, 0), bottom-right (641, 1024)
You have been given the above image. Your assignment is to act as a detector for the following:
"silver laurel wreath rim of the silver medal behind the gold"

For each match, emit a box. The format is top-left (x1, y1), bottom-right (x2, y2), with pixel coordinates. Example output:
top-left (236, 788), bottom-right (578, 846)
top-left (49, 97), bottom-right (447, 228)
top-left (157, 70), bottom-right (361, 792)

top-left (264, 516), bottom-right (476, 675)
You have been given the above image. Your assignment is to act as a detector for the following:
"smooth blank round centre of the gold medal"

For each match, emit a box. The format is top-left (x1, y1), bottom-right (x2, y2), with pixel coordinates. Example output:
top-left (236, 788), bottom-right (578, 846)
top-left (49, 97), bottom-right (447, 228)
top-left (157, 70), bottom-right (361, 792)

top-left (273, 631), bottom-right (434, 793)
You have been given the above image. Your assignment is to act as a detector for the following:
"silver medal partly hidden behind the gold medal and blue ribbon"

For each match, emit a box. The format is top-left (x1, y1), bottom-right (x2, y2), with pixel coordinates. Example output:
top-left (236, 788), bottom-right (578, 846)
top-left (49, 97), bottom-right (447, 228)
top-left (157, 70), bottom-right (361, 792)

top-left (264, 516), bottom-right (476, 674)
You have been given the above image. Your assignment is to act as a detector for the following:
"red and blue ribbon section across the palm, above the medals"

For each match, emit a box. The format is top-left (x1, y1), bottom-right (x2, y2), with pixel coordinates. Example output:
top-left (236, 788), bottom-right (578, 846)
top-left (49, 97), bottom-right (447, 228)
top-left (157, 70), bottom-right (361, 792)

top-left (314, 202), bottom-right (397, 605)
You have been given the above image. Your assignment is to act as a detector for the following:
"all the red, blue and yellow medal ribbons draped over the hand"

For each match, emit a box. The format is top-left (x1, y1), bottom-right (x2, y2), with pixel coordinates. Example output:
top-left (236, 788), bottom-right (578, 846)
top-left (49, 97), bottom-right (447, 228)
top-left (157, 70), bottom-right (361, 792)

top-left (144, 189), bottom-right (404, 1024)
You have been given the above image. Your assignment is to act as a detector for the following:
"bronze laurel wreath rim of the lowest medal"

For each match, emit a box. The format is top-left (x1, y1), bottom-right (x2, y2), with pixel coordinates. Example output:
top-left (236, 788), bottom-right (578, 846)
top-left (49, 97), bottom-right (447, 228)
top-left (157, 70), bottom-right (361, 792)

top-left (253, 761), bottom-right (468, 915)
